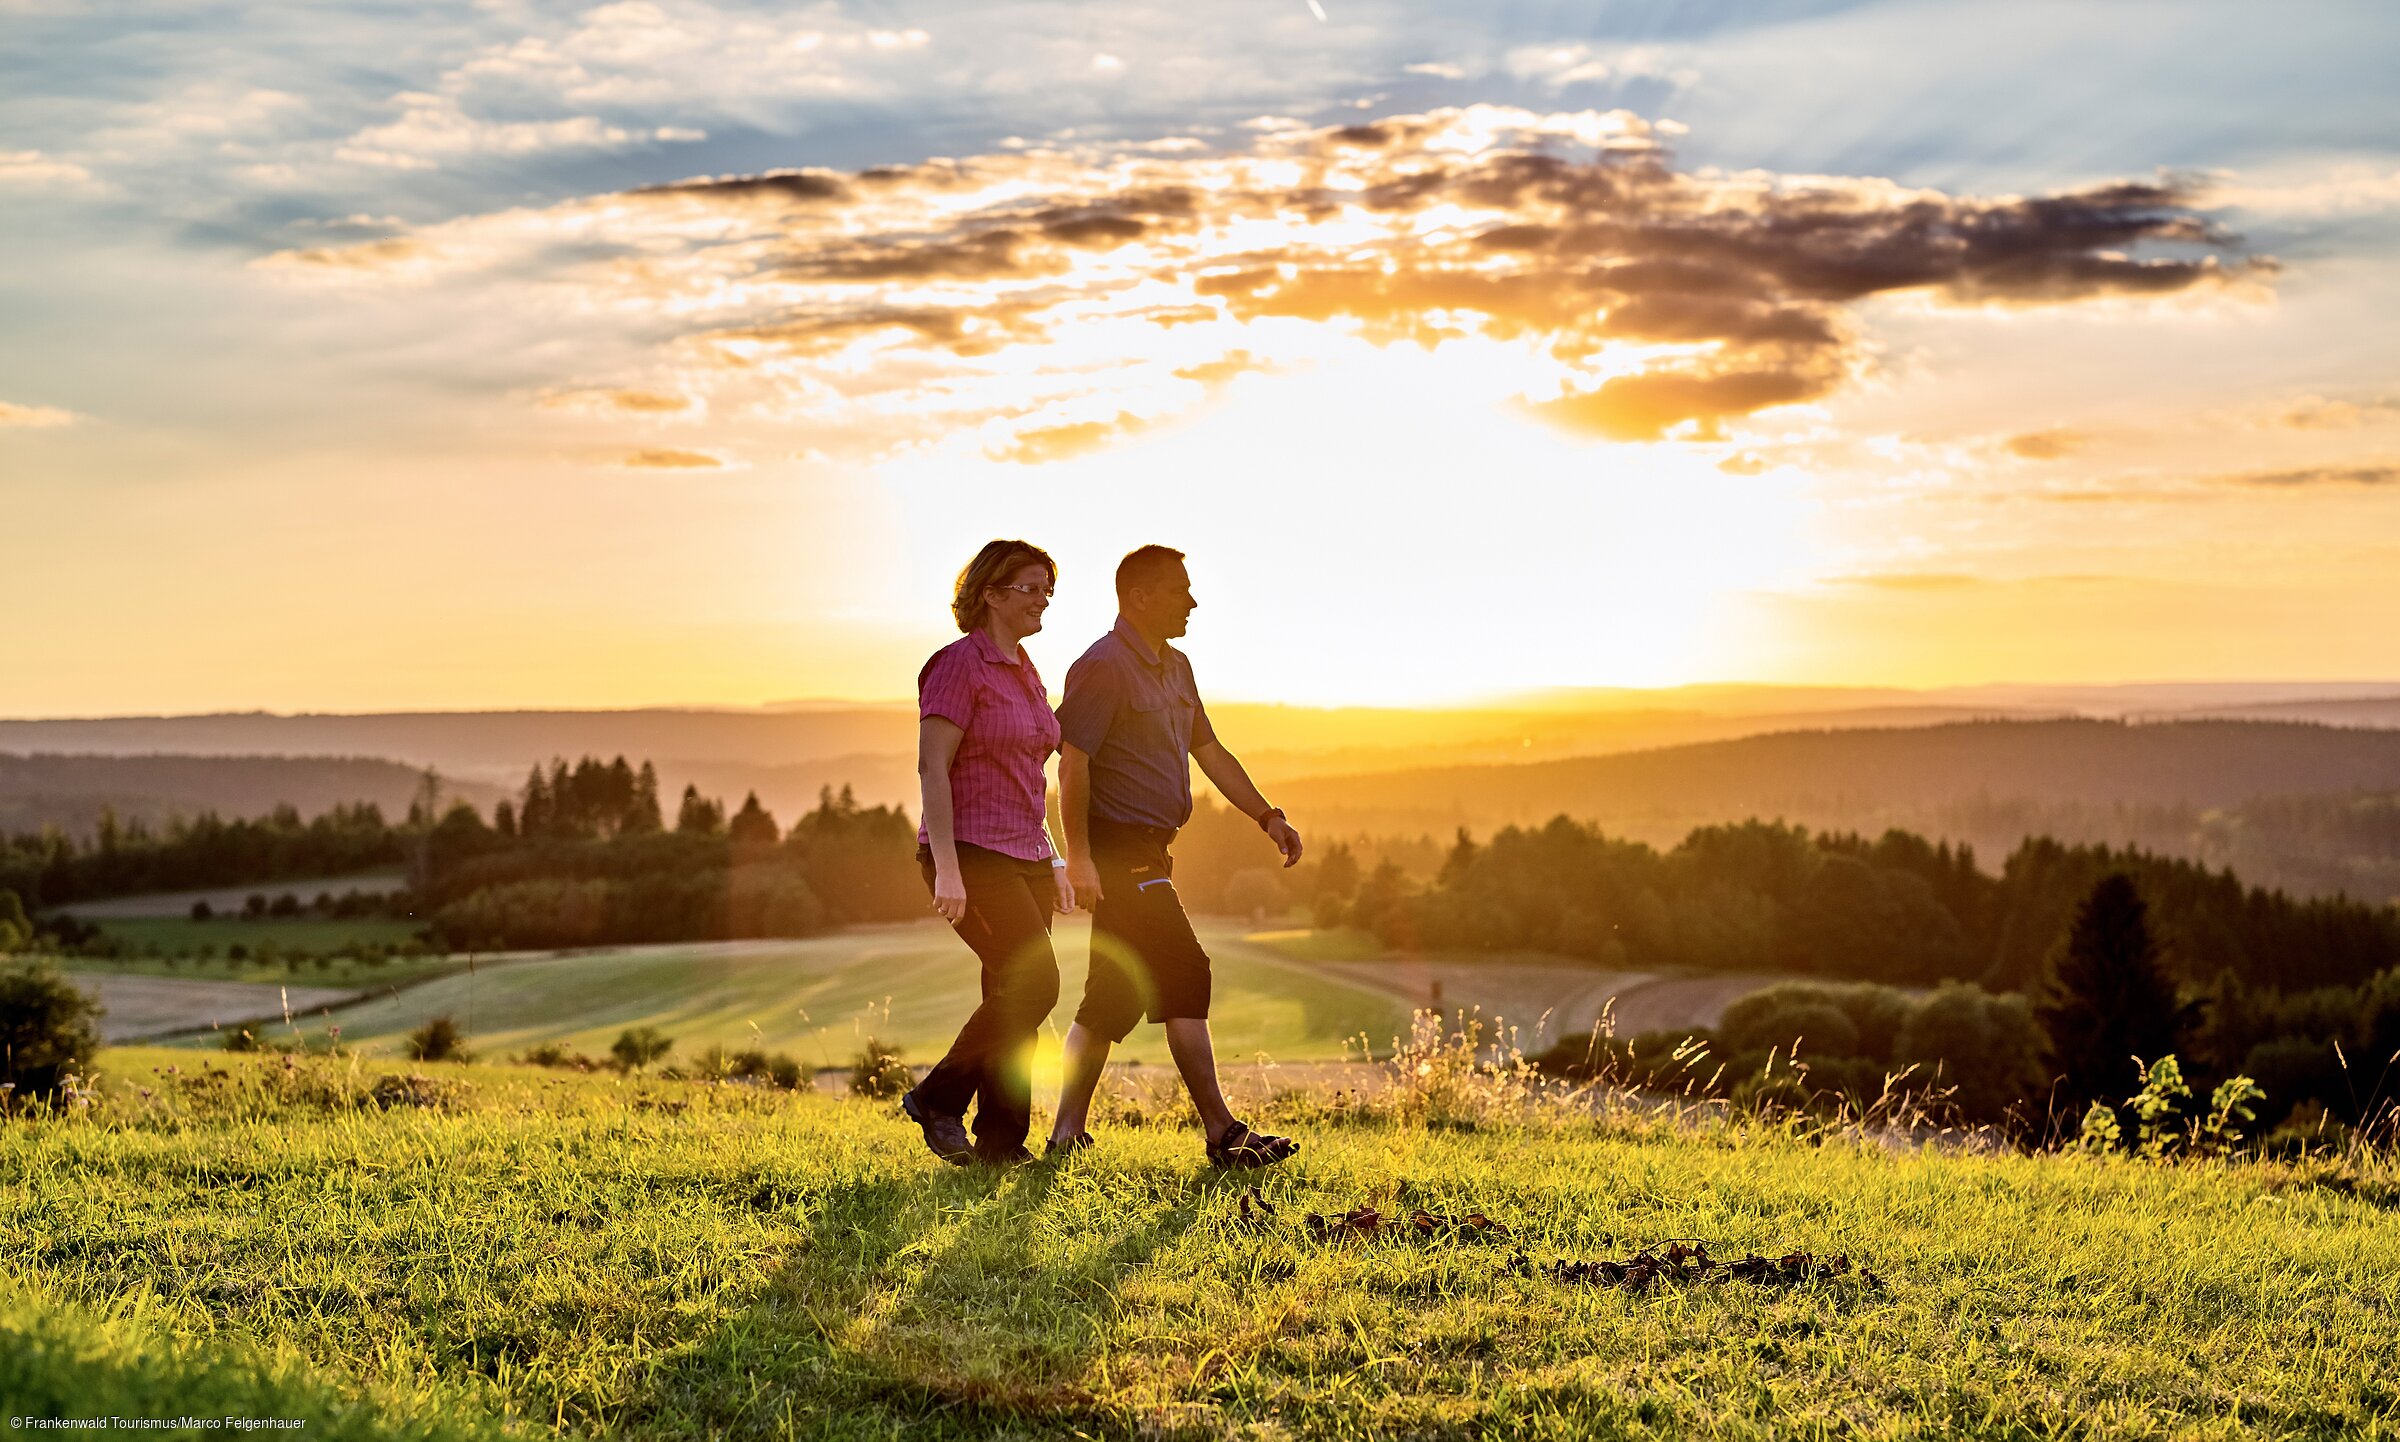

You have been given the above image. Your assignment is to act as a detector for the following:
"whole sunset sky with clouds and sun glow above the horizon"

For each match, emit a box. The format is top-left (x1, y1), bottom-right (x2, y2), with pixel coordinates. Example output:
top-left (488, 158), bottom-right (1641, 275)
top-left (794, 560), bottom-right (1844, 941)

top-left (0, 0), bottom-right (2400, 715)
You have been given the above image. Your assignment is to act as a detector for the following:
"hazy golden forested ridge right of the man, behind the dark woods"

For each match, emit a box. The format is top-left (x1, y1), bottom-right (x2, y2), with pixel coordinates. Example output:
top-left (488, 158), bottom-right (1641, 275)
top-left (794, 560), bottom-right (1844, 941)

top-left (1272, 720), bottom-right (2400, 902)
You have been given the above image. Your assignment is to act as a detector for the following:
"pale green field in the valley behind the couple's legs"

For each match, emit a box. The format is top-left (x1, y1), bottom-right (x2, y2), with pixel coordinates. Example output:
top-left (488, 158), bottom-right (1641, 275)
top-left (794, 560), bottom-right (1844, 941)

top-left (192, 917), bottom-right (1409, 1065)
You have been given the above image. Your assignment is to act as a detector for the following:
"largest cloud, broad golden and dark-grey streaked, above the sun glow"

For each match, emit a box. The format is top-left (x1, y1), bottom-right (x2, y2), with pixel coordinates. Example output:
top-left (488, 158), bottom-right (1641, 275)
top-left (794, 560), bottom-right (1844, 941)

top-left (266, 106), bottom-right (2275, 458)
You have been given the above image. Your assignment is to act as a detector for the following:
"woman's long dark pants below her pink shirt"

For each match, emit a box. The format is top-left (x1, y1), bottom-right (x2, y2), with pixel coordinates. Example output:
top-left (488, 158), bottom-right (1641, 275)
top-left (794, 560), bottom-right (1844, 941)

top-left (917, 842), bottom-right (1058, 1161)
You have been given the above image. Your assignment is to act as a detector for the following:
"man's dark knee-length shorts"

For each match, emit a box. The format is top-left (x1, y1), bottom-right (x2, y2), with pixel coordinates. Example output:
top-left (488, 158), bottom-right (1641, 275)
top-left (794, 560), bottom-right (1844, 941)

top-left (1075, 816), bottom-right (1210, 1041)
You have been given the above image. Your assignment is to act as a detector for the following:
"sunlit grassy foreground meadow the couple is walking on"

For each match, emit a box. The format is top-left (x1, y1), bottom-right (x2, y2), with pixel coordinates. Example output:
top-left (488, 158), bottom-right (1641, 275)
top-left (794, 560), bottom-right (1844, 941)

top-left (0, 1051), bottom-right (2400, 1440)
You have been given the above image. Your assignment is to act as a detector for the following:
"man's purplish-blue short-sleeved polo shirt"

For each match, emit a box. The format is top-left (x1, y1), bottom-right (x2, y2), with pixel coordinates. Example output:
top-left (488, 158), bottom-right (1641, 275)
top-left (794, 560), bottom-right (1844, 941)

top-left (1058, 617), bottom-right (1217, 828)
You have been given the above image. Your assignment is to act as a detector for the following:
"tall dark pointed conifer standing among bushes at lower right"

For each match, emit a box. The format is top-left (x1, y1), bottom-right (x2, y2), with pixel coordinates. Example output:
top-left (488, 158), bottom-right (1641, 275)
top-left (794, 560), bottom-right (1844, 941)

top-left (2033, 871), bottom-right (2186, 1118)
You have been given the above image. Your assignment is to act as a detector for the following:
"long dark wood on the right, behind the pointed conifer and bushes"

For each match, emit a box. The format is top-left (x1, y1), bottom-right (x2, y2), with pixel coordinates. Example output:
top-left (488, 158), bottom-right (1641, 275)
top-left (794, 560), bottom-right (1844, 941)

top-left (1346, 816), bottom-right (2400, 991)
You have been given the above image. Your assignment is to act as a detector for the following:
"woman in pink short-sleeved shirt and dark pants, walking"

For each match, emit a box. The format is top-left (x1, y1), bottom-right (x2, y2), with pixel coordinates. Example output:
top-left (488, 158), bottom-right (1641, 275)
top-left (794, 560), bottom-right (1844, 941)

top-left (900, 540), bottom-right (1075, 1166)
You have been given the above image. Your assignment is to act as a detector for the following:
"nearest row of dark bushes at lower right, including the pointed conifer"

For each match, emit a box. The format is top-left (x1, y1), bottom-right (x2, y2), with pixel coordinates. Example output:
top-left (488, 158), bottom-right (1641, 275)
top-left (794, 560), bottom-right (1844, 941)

top-left (1546, 845), bottom-right (2400, 1137)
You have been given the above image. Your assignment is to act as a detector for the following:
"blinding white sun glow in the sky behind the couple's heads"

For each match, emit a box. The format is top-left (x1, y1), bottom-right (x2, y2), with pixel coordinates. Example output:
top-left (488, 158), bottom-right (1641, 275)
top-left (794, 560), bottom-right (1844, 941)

top-left (883, 329), bottom-right (1817, 703)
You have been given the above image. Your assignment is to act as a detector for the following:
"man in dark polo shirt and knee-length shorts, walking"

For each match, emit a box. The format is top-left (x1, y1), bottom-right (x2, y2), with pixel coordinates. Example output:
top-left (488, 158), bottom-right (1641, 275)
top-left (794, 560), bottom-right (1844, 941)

top-left (1049, 545), bottom-right (1301, 1166)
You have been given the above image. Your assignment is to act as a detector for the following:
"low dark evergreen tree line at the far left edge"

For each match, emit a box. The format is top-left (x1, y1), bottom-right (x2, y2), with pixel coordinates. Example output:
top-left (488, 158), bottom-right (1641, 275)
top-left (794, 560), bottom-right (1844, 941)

top-left (0, 801), bottom-right (403, 907)
